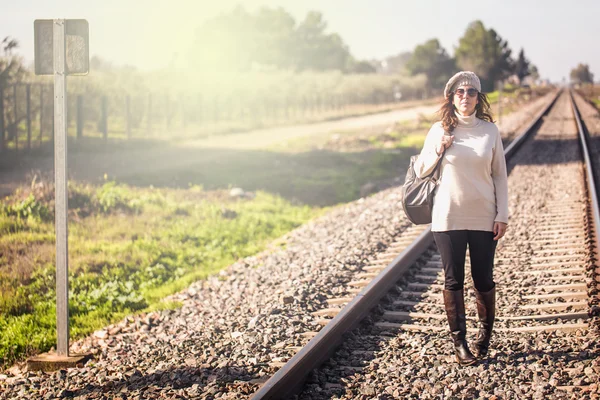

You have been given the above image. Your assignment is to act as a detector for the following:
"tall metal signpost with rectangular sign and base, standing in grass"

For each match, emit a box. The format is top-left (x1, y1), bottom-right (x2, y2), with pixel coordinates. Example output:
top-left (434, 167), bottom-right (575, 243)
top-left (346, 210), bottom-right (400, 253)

top-left (27, 19), bottom-right (89, 370)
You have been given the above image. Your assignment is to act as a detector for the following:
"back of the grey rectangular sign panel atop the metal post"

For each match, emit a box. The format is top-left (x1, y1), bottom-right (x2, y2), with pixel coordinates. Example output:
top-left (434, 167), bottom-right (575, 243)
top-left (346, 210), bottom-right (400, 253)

top-left (33, 19), bottom-right (90, 75)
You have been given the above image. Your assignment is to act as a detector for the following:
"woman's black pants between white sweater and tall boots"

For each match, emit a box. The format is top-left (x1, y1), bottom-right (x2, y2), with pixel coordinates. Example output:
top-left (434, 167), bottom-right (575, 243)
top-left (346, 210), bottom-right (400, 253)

top-left (433, 230), bottom-right (498, 292)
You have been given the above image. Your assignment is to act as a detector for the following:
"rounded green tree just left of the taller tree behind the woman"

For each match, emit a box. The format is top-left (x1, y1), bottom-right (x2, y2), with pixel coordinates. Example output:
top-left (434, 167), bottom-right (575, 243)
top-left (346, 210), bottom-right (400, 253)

top-left (406, 39), bottom-right (456, 88)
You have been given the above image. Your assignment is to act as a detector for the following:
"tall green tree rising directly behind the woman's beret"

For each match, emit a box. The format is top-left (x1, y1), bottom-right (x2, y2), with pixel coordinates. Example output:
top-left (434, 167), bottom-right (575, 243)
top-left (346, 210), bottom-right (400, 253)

top-left (455, 21), bottom-right (513, 91)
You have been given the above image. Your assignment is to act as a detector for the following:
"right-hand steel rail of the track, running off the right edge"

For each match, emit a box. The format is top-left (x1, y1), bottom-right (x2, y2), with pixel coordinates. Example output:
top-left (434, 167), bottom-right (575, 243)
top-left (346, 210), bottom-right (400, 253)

top-left (569, 90), bottom-right (600, 296)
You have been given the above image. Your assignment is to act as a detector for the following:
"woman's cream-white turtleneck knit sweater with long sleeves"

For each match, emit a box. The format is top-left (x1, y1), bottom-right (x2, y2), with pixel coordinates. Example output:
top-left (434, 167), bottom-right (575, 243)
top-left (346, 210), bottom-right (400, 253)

top-left (414, 114), bottom-right (508, 232)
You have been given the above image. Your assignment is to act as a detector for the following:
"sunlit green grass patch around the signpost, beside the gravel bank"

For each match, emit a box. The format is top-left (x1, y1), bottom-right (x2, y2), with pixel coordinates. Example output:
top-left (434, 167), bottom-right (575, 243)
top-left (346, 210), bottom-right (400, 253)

top-left (0, 182), bottom-right (324, 366)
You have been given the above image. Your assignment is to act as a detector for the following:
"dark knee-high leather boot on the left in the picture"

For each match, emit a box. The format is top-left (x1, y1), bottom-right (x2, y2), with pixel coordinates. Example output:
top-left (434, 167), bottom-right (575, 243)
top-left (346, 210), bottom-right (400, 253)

top-left (444, 289), bottom-right (477, 365)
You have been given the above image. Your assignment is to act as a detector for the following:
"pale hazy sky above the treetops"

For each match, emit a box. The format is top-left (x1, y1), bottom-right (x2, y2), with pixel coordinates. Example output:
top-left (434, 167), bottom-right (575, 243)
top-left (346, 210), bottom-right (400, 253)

top-left (0, 0), bottom-right (600, 82)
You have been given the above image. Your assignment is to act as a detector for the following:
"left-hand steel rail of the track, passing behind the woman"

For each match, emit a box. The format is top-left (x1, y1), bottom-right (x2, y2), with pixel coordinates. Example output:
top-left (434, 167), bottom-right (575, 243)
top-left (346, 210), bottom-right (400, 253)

top-left (252, 90), bottom-right (562, 400)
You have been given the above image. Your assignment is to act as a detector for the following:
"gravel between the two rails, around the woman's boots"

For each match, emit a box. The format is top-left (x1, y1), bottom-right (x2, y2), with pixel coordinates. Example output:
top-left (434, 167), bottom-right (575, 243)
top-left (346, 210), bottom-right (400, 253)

top-left (298, 91), bottom-right (600, 399)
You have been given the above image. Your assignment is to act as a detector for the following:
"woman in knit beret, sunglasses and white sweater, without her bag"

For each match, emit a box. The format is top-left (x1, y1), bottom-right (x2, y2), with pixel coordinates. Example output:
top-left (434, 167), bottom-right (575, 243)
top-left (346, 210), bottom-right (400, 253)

top-left (414, 71), bottom-right (508, 365)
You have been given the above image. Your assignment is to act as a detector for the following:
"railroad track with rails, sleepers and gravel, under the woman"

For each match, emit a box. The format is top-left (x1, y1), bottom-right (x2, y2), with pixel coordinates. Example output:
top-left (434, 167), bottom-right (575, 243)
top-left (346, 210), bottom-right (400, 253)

top-left (253, 91), bottom-right (600, 399)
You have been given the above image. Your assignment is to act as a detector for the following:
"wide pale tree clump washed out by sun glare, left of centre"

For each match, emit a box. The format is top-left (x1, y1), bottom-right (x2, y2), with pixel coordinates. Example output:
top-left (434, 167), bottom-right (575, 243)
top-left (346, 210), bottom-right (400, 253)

top-left (191, 6), bottom-right (354, 71)
